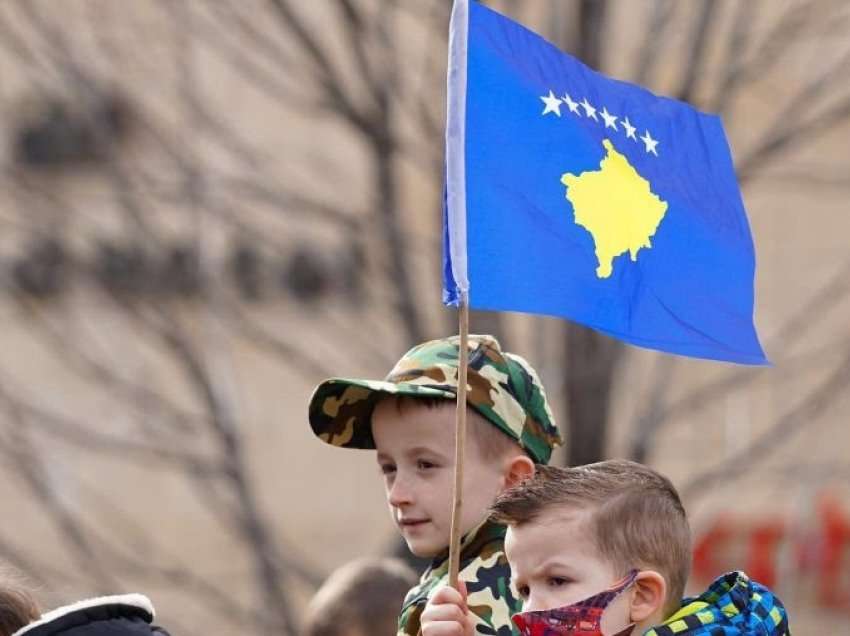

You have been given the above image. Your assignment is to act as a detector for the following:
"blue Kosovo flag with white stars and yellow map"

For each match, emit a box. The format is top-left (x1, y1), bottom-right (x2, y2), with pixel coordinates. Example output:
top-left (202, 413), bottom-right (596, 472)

top-left (443, 0), bottom-right (768, 364)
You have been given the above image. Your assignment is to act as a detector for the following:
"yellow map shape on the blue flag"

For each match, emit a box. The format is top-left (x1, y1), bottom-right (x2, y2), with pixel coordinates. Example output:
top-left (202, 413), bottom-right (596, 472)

top-left (561, 139), bottom-right (667, 278)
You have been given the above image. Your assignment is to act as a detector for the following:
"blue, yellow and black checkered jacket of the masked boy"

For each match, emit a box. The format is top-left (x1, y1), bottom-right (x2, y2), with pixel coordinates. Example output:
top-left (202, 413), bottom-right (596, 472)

top-left (644, 572), bottom-right (791, 636)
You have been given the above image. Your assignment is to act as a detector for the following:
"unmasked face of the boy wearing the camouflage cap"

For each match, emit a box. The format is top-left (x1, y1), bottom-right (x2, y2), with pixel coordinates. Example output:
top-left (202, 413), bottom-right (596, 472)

top-left (372, 399), bottom-right (505, 557)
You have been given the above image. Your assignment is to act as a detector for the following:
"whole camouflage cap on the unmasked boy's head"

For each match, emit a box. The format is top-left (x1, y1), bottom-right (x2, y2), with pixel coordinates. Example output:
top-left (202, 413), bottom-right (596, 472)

top-left (310, 335), bottom-right (562, 464)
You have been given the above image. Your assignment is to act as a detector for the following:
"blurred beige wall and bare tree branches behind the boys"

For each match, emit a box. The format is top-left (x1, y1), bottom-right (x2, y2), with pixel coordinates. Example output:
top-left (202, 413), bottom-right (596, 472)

top-left (0, 0), bottom-right (850, 635)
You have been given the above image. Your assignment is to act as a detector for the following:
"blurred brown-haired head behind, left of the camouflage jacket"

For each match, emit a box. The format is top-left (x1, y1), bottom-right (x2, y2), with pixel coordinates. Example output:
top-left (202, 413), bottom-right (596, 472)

top-left (301, 558), bottom-right (416, 636)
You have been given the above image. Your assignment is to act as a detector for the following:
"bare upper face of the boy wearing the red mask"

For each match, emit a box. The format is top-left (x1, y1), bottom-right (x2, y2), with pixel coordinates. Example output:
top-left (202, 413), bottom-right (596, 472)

top-left (505, 506), bottom-right (630, 633)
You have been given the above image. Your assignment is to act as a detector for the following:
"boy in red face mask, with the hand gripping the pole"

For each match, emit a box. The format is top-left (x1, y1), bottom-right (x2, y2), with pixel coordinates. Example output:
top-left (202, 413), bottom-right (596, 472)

top-left (422, 460), bottom-right (790, 636)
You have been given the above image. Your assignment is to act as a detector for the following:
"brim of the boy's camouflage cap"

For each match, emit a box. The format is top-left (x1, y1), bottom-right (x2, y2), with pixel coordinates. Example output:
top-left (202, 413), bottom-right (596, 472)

top-left (309, 378), bottom-right (456, 448)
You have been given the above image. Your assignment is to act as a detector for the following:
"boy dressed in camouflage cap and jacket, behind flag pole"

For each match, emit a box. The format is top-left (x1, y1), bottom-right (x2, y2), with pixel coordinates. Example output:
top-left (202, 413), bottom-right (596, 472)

top-left (310, 335), bottom-right (561, 636)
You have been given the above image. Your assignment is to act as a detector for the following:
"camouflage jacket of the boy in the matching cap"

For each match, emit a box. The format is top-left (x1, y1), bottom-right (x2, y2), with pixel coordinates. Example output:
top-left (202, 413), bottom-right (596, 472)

top-left (398, 521), bottom-right (521, 636)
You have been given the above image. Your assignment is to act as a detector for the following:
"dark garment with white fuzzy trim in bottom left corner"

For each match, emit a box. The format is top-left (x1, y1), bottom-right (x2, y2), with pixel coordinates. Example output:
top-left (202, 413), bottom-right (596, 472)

top-left (12, 594), bottom-right (168, 636)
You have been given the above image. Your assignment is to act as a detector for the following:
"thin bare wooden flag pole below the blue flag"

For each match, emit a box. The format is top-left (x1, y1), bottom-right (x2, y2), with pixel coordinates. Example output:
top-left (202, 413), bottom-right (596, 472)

top-left (449, 293), bottom-right (469, 589)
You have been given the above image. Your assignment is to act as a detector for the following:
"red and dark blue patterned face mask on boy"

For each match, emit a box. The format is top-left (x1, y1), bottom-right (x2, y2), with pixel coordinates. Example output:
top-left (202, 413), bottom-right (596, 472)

top-left (513, 570), bottom-right (638, 636)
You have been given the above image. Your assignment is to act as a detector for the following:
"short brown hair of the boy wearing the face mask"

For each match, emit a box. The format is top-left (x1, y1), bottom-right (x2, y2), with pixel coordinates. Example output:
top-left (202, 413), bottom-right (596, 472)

top-left (492, 460), bottom-right (691, 614)
